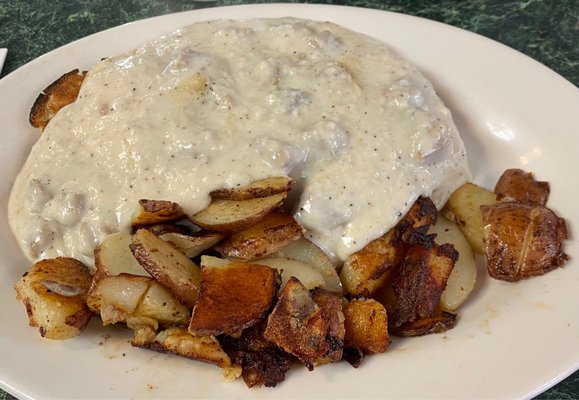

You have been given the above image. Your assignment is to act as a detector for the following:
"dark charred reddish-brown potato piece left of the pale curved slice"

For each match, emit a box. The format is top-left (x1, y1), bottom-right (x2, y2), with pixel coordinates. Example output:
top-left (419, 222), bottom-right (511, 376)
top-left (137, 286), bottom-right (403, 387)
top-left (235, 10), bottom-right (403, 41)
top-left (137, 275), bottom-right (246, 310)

top-left (389, 243), bottom-right (458, 328)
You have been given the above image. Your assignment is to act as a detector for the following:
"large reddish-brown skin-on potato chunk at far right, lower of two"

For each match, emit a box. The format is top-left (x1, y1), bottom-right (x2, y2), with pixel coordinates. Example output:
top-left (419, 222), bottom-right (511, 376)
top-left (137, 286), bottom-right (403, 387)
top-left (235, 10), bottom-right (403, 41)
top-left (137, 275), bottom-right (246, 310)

top-left (482, 202), bottom-right (568, 281)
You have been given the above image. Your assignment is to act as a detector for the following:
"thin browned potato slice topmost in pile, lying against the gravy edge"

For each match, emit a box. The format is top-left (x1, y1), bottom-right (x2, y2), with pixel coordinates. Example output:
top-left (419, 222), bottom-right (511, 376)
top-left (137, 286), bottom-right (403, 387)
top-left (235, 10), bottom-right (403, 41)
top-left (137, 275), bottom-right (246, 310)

top-left (211, 176), bottom-right (294, 201)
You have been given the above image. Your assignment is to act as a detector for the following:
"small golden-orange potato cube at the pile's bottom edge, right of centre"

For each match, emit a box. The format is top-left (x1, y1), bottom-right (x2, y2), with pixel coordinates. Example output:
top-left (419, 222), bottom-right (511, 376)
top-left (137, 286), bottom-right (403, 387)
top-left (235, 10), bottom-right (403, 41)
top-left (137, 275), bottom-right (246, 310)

top-left (344, 299), bottom-right (390, 354)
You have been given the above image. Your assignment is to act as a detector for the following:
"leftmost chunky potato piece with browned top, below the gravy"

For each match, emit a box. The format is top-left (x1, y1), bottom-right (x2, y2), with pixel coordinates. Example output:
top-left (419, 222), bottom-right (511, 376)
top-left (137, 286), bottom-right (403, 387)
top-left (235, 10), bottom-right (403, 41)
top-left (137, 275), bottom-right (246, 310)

top-left (15, 258), bottom-right (92, 340)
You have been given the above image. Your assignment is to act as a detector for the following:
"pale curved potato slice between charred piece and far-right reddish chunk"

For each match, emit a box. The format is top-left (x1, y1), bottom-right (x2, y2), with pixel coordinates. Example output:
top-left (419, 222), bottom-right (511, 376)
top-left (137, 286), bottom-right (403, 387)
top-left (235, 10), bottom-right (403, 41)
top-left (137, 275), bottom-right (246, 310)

top-left (428, 216), bottom-right (477, 311)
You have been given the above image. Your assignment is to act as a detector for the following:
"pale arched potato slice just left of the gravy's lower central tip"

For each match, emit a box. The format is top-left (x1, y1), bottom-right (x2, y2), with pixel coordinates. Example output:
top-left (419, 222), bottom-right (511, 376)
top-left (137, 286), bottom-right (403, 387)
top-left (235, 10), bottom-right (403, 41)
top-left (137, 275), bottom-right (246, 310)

top-left (270, 238), bottom-right (342, 293)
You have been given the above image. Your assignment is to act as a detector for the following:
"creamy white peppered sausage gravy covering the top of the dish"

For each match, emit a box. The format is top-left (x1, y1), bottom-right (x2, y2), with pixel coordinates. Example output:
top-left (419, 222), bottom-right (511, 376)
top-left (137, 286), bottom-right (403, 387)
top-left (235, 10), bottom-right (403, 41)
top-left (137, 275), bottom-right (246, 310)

top-left (9, 18), bottom-right (469, 263)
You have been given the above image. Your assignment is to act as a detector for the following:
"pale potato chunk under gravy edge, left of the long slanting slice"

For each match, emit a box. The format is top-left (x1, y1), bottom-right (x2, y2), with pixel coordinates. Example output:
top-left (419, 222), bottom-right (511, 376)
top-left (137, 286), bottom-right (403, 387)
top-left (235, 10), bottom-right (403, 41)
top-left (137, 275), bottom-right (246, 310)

top-left (94, 233), bottom-right (151, 281)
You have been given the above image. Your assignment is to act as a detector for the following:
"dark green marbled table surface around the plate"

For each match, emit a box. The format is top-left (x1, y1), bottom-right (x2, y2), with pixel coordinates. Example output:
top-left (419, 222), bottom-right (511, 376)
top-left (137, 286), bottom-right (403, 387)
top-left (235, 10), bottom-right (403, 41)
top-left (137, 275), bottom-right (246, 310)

top-left (0, 0), bottom-right (579, 400)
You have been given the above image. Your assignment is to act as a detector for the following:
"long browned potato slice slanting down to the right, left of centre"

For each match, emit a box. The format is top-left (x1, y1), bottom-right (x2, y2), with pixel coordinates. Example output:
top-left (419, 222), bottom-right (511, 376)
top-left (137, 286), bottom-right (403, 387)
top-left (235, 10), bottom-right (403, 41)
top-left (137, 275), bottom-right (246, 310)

top-left (130, 229), bottom-right (200, 307)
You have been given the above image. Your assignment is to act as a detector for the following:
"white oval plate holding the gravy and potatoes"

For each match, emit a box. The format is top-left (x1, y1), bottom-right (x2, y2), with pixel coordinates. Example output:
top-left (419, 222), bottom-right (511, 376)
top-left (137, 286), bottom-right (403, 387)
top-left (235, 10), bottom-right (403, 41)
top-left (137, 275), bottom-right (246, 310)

top-left (0, 5), bottom-right (579, 399)
